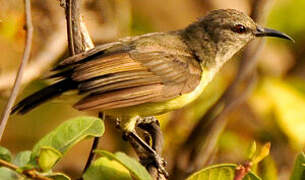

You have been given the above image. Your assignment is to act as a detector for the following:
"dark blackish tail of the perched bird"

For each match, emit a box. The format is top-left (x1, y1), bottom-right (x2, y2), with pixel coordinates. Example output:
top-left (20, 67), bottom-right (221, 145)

top-left (11, 79), bottom-right (77, 114)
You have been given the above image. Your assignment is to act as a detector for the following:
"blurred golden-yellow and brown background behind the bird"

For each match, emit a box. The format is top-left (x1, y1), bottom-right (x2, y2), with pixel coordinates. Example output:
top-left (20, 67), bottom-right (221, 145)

top-left (0, 0), bottom-right (305, 180)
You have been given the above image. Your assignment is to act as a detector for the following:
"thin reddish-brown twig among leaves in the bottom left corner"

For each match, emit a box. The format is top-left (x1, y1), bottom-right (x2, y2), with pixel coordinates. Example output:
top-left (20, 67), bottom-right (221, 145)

top-left (0, 159), bottom-right (52, 180)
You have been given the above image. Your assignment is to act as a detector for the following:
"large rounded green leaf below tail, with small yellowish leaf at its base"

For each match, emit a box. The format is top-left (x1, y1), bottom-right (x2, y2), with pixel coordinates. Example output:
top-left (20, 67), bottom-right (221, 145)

top-left (31, 116), bottom-right (104, 171)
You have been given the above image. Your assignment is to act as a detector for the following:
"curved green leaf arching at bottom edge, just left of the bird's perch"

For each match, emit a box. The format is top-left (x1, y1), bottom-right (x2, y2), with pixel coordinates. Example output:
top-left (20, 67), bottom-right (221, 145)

top-left (95, 150), bottom-right (152, 180)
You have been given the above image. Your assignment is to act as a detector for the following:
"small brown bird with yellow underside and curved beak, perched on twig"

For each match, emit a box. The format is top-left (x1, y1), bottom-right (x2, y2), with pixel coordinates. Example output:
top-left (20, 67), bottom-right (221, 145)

top-left (12, 9), bottom-right (293, 174)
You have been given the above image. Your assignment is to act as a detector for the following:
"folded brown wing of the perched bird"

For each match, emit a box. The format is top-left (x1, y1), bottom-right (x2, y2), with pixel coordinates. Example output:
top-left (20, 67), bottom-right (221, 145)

top-left (72, 49), bottom-right (201, 110)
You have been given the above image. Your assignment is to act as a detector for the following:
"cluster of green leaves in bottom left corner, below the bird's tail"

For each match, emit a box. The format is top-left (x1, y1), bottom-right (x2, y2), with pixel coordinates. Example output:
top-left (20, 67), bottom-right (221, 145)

top-left (0, 116), bottom-right (104, 180)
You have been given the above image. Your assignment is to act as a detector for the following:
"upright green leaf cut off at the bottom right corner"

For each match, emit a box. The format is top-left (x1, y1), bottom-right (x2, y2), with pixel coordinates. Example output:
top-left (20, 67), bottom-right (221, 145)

top-left (290, 152), bottom-right (305, 180)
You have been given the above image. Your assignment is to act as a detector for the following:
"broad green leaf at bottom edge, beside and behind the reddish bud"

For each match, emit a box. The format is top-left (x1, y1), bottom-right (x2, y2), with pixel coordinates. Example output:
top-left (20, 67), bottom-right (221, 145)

top-left (187, 164), bottom-right (261, 180)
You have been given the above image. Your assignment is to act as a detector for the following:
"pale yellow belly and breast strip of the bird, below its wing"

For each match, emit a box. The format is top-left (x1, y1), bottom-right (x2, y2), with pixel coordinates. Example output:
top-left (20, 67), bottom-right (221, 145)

top-left (105, 68), bottom-right (217, 119)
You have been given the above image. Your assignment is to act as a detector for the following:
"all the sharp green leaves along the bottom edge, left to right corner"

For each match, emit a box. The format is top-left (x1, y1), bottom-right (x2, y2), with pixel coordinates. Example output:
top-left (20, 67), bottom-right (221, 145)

top-left (0, 116), bottom-right (305, 180)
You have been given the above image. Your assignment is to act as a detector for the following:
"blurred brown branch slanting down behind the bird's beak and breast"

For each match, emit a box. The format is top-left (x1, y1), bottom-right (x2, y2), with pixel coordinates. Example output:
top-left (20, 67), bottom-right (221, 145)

top-left (173, 0), bottom-right (271, 177)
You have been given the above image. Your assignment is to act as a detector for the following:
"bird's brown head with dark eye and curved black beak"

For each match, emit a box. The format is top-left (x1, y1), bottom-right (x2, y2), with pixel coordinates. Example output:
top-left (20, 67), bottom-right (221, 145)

top-left (199, 9), bottom-right (293, 62)
